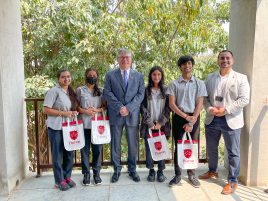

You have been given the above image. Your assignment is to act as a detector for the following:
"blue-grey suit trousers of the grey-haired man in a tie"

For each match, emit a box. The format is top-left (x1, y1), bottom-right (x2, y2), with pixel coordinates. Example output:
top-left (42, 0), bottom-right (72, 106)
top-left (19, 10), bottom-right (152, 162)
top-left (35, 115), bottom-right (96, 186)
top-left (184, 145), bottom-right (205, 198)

top-left (111, 125), bottom-right (138, 172)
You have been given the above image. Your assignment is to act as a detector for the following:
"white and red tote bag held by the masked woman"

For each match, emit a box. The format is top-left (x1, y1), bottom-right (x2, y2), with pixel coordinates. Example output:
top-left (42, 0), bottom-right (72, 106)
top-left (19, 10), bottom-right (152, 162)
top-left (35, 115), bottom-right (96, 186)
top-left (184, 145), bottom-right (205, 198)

top-left (91, 113), bottom-right (111, 144)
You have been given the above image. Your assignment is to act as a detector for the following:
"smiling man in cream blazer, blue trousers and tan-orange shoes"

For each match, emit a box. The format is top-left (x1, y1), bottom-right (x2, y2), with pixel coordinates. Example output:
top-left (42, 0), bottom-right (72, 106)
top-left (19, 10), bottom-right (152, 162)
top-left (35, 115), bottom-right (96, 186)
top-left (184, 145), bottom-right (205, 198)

top-left (199, 50), bottom-right (250, 195)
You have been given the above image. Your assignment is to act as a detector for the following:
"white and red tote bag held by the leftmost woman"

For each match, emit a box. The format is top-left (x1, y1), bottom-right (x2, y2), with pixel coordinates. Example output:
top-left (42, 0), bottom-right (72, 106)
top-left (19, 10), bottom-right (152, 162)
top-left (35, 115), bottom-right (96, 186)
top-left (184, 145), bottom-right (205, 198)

top-left (62, 115), bottom-right (85, 151)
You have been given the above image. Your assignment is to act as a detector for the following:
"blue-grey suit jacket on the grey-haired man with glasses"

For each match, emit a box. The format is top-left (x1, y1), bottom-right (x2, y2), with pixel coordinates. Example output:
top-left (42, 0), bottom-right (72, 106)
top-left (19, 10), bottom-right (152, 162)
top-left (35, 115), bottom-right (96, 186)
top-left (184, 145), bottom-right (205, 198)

top-left (103, 68), bottom-right (145, 126)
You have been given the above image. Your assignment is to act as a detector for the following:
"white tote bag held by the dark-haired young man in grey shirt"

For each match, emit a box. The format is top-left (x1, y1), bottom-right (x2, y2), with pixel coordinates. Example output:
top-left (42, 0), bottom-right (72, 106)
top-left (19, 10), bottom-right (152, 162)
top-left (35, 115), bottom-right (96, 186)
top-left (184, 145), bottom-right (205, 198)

top-left (177, 132), bottom-right (198, 169)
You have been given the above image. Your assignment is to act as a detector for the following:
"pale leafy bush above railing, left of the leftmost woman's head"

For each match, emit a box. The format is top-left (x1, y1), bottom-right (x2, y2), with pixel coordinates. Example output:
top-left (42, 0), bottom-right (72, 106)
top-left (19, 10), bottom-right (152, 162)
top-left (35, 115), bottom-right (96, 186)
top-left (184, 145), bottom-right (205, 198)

top-left (25, 75), bottom-right (55, 98)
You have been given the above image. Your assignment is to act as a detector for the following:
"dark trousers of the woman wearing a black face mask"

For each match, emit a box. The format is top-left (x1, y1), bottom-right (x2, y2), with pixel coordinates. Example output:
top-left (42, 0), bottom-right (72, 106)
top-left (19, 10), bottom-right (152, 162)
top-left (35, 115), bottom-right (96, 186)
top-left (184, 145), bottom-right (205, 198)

top-left (81, 129), bottom-right (103, 174)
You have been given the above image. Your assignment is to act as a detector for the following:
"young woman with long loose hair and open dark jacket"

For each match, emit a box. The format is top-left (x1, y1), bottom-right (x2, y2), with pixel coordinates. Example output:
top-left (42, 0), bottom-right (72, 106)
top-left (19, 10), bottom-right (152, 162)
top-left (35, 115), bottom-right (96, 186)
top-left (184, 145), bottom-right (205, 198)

top-left (140, 66), bottom-right (170, 182)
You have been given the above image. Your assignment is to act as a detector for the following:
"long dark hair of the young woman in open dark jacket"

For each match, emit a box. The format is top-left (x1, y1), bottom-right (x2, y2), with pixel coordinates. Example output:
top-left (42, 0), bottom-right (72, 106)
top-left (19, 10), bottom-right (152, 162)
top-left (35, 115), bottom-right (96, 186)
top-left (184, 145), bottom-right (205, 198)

top-left (146, 66), bottom-right (165, 98)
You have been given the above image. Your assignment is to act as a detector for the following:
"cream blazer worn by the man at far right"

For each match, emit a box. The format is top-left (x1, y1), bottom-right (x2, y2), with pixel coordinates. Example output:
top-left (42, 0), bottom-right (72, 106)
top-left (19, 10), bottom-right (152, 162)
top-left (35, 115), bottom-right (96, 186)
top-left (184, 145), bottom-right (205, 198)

top-left (204, 70), bottom-right (250, 129)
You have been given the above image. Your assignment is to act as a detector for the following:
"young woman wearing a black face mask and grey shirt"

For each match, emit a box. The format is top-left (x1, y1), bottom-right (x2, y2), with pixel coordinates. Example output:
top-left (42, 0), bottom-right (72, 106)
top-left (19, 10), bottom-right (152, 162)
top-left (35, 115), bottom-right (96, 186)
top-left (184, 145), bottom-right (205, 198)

top-left (76, 68), bottom-right (106, 186)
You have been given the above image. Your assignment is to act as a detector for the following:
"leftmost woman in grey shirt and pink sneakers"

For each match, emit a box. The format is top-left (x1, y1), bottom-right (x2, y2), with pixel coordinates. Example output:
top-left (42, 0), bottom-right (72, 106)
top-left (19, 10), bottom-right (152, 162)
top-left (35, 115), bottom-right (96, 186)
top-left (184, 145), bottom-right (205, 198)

top-left (43, 69), bottom-right (78, 191)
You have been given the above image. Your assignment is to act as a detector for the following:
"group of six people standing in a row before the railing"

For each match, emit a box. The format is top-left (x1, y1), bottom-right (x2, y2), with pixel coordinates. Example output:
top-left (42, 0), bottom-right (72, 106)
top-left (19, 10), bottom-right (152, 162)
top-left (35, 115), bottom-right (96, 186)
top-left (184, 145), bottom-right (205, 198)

top-left (43, 48), bottom-right (250, 194)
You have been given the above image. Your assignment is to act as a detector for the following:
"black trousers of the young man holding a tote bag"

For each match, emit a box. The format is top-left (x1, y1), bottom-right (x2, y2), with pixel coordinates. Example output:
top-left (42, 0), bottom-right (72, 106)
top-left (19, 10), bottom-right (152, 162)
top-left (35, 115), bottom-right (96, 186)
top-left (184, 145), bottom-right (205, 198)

top-left (172, 114), bottom-right (200, 176)
